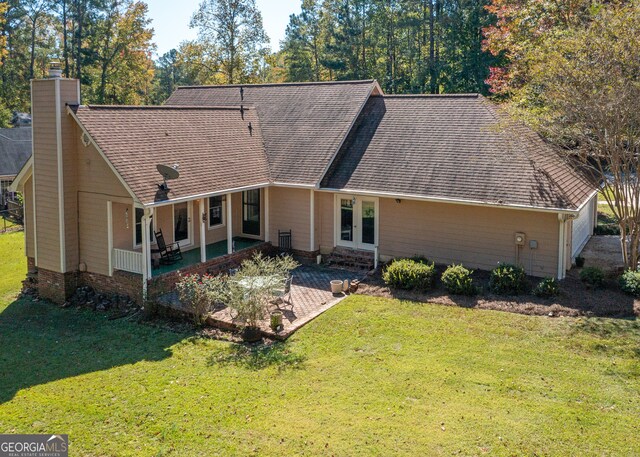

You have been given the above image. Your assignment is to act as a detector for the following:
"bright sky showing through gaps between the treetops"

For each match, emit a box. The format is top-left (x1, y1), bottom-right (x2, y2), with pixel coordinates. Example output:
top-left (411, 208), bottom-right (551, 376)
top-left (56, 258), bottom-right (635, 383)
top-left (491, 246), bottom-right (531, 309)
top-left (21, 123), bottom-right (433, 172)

top-left (147, 0), bottom-right (301, 55)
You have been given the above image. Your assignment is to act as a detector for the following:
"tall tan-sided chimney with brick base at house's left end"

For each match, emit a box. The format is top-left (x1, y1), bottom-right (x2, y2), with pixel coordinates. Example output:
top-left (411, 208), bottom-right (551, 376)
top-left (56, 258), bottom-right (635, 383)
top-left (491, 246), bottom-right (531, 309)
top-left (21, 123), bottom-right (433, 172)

top-left (31, 62), bottom-right (80, 303)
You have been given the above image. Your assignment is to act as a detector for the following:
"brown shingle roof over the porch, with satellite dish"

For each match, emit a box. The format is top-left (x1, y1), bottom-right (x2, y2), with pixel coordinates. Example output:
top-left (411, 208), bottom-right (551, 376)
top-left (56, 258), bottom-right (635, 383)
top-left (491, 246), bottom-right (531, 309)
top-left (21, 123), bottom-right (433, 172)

top-left (72, 106), bottom-right (269, 205)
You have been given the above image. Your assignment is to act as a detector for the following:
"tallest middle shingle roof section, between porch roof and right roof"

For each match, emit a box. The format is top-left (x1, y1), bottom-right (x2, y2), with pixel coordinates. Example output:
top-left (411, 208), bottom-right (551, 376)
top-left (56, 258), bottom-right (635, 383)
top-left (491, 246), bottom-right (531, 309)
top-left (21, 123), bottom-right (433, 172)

top-left (165, 80), bottom-right (379, 186)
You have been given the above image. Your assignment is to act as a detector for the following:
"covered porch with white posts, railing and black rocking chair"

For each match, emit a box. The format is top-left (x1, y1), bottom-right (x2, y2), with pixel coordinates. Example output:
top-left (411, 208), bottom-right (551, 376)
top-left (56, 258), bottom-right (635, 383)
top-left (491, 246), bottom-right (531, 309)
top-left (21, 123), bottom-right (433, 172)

top-left (107, 187), bottom-right (269, 282)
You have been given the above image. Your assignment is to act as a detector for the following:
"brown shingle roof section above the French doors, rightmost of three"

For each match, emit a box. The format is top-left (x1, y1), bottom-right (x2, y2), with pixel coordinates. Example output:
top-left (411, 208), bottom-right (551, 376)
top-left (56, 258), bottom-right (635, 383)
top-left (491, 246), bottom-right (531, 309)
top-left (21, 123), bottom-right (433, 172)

top-left (321, 94), bottom-right (594, 210)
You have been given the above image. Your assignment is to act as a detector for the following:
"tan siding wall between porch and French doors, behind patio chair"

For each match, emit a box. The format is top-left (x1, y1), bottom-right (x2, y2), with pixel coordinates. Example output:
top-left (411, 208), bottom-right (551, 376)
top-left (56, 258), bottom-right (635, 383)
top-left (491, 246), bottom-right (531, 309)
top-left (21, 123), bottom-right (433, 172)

top-left (269, 187), bottom-right (310, 251)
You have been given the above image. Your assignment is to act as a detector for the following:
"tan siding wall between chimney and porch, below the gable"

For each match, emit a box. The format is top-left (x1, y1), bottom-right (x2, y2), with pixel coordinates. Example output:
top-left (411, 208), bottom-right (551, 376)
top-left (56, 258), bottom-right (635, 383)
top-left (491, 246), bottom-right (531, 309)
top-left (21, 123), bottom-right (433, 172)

top-left (78, 192), bottom-right (109, 275)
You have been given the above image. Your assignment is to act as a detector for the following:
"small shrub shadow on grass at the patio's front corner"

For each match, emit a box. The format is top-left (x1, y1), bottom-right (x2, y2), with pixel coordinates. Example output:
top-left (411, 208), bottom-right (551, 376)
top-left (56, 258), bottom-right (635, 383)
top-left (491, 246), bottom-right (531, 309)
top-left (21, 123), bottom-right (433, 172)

top-left (208, 342), bottom-right (305, 371)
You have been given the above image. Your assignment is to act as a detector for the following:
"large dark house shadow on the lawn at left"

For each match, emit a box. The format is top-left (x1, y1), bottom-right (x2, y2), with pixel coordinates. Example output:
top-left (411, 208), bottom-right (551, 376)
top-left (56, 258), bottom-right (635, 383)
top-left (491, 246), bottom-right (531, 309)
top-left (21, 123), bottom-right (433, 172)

top-left (0, 298), bottom-right (189, 404)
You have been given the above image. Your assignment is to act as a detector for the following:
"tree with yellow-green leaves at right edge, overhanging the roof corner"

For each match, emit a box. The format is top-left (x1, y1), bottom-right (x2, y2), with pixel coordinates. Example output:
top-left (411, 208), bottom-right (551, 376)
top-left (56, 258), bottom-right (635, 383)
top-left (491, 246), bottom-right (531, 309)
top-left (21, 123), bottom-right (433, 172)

top-left (485, 0), bottom-right (640, 270)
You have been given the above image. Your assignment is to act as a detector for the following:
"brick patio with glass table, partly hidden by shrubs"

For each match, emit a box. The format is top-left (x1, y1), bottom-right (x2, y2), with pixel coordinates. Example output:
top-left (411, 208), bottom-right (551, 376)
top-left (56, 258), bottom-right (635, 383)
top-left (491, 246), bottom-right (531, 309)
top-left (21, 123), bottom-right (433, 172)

top-left (158, 265), bottom-right (364, 339)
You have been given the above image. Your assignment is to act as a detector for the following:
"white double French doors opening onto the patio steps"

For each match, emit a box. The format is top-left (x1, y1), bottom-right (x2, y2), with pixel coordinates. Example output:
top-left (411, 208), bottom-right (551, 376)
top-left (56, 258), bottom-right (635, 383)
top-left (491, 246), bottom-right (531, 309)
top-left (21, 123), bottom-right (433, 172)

top-left (335, 194), bottom-right (378, 250)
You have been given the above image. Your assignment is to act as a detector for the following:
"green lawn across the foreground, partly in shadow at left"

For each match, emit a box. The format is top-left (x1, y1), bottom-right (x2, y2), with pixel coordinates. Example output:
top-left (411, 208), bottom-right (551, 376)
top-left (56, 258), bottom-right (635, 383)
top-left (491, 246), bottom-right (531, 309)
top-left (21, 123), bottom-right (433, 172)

top-left (0, 235), bottom-right (640, 456)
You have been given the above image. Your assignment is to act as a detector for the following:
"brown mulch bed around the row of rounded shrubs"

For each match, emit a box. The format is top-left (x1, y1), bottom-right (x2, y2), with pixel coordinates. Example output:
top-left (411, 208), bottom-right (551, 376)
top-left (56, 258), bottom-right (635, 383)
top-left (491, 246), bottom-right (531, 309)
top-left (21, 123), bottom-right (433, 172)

top-left (357, 268), bottom-right (640, 318)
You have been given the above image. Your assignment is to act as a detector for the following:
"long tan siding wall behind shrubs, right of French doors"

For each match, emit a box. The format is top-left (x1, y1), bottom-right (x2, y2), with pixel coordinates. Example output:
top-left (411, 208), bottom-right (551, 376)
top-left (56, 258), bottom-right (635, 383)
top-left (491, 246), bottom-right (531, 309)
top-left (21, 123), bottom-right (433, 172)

top-left (379, 198), bottom-right (558, 276)
